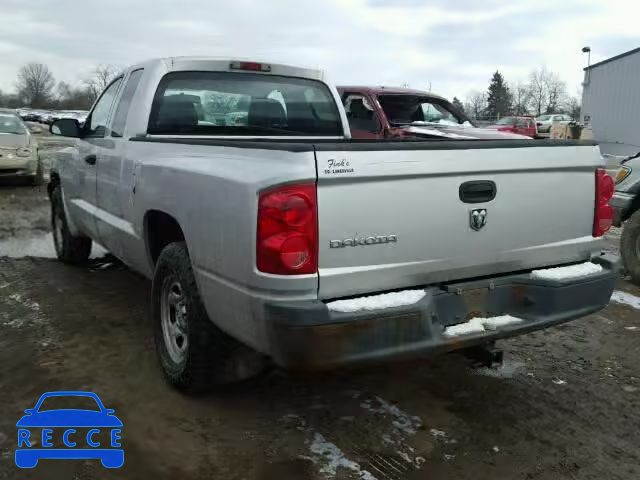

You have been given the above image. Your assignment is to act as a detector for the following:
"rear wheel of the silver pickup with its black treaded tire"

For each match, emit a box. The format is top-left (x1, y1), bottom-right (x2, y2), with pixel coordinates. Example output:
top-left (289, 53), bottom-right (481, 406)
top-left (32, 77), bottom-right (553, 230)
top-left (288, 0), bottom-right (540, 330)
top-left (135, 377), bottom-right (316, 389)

top-left (151, 242), bottom-right (265, 392)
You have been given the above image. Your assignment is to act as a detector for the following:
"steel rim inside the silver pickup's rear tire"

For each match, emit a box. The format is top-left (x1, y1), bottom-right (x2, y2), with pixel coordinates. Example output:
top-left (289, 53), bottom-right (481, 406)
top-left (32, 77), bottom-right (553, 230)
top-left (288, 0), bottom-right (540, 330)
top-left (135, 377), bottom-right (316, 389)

top-left (160, 276), bottom-right (189, 364)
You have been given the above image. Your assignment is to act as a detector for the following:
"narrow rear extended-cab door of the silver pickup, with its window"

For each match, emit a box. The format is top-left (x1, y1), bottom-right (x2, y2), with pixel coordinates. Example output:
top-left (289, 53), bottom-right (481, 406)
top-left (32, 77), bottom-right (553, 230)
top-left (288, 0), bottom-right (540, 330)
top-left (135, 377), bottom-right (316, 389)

top-left (96, 69), bottom-right (143, 259)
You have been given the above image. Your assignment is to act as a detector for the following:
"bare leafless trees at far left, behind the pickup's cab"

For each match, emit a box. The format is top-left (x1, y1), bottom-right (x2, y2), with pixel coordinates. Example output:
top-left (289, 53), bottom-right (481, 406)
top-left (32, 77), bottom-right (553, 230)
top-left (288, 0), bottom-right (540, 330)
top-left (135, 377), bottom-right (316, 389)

top-left (0, 63), bottom-right (118, 110)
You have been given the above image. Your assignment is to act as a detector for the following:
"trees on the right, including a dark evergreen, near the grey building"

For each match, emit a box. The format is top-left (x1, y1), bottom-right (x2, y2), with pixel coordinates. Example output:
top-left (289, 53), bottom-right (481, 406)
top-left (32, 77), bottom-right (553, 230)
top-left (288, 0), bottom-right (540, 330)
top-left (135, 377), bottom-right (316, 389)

top-left (453, 67), bottom-right (580, 120)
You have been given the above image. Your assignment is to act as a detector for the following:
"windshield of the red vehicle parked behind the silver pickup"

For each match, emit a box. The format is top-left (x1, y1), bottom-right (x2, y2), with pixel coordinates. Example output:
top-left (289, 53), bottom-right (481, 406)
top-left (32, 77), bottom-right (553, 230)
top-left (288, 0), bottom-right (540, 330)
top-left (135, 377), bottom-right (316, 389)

top-left (378, 94), bottom-right (467, 125)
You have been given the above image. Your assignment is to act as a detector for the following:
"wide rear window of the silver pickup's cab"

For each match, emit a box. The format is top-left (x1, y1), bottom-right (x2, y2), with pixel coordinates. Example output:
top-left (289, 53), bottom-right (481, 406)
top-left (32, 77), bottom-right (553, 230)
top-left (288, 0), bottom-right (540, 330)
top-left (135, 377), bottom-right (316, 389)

top-left (148, 72), bottom-right (343, 136)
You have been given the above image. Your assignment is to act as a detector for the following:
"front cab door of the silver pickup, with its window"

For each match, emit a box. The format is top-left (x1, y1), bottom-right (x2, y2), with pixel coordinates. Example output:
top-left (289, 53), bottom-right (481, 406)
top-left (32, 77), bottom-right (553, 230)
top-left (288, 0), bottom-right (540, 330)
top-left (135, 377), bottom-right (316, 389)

top-left (65, 77), bottom-right (122, 241)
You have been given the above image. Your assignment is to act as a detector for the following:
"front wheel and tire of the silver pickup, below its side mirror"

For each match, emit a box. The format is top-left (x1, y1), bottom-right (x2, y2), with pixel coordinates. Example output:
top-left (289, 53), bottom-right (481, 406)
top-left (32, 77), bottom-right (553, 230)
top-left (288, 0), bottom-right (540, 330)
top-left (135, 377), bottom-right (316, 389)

top-left (51, 185), bottom-right (91, 265)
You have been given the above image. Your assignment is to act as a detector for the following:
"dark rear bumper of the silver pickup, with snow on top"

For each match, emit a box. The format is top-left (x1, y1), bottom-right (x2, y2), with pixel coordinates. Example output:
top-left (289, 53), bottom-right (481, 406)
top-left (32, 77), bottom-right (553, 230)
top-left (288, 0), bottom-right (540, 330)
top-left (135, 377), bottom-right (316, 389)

top-left (265, 255), bottom-right (618, 370)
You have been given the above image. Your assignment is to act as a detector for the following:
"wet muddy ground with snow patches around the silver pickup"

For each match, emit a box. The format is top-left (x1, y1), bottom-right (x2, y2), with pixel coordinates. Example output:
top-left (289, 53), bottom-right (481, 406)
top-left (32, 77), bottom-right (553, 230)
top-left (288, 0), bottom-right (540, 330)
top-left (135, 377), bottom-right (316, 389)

top-left (0, 144), bottom-right (640, 480)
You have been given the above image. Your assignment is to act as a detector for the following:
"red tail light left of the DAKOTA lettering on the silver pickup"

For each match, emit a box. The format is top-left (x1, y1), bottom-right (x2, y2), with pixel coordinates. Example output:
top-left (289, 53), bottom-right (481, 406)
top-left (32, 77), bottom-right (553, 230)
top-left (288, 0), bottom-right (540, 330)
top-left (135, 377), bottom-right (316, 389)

top-left (256, 183), bottom-right (318, 275)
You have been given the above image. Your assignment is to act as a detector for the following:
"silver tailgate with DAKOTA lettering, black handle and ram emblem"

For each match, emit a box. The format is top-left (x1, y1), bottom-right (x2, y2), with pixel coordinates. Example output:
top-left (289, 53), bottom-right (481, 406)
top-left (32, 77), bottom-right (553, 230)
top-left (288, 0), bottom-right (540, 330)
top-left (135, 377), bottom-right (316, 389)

top-left (316, 140), bottom-right (602, 299)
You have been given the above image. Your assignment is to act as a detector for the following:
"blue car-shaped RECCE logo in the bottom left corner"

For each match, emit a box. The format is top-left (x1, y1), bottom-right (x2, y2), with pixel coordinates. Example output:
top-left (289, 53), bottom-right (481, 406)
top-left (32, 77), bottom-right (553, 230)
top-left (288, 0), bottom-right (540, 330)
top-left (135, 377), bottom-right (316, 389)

top-left (16, 391), bottom-right (124, 468)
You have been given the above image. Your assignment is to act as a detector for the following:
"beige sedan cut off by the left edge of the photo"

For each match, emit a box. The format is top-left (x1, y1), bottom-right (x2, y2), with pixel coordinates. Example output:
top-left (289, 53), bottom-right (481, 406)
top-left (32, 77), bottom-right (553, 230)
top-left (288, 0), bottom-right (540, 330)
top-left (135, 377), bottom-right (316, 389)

top-left (0, 110), bottom-right (43, 185)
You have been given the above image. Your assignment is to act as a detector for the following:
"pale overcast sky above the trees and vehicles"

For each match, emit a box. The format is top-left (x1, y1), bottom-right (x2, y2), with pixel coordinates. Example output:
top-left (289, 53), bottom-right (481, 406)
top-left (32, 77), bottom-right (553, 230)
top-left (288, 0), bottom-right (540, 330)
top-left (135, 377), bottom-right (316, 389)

top-left (0, 0), bottom-right (640, 98)
